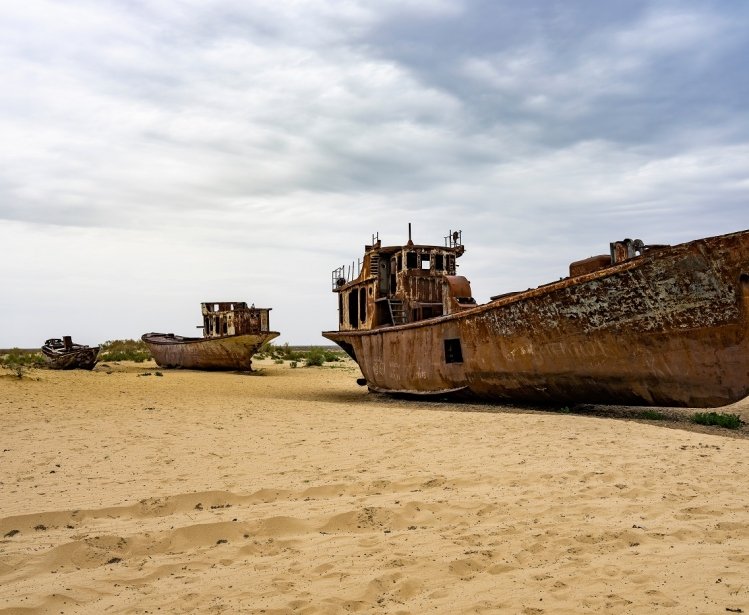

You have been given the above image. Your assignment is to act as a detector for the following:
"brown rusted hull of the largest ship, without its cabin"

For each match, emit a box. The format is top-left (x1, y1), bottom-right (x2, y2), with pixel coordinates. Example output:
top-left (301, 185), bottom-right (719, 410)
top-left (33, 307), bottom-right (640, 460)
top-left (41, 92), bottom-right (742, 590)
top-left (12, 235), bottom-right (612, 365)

top-left (323, 231), bottom-right (749, 407)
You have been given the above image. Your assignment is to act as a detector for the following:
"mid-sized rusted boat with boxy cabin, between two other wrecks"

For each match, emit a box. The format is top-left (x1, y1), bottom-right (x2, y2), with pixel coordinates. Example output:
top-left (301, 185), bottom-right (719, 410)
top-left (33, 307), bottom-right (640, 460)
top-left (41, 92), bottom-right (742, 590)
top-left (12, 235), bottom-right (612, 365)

top-left (141, 301), bottom-right (279, 371)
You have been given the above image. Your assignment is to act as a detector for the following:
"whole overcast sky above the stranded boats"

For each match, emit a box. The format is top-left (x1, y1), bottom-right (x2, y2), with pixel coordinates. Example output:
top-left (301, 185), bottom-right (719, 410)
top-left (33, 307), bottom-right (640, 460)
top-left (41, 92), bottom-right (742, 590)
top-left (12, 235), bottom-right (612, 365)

top-left (0, 0), bottom-right (749, 348)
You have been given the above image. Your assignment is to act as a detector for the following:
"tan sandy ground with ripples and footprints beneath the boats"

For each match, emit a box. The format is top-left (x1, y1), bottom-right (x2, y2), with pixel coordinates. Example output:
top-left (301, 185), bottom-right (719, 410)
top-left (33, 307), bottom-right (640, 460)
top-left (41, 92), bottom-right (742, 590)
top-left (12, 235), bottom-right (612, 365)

top-left (0, 362), bottom-right (749, 614)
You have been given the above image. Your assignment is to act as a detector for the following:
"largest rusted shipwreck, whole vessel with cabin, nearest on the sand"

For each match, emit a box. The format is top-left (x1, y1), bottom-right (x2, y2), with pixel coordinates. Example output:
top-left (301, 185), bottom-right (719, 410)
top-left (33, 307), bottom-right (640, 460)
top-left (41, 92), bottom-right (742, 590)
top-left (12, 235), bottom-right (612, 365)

top-left (323, 231), bottom-right (749, 407)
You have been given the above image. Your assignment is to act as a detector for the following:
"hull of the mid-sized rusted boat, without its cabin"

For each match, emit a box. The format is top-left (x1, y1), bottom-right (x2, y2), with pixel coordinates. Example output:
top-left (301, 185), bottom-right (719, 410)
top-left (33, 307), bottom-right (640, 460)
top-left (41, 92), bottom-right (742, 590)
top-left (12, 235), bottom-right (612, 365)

top-left (141, 331), bottom-right (279, 371)
